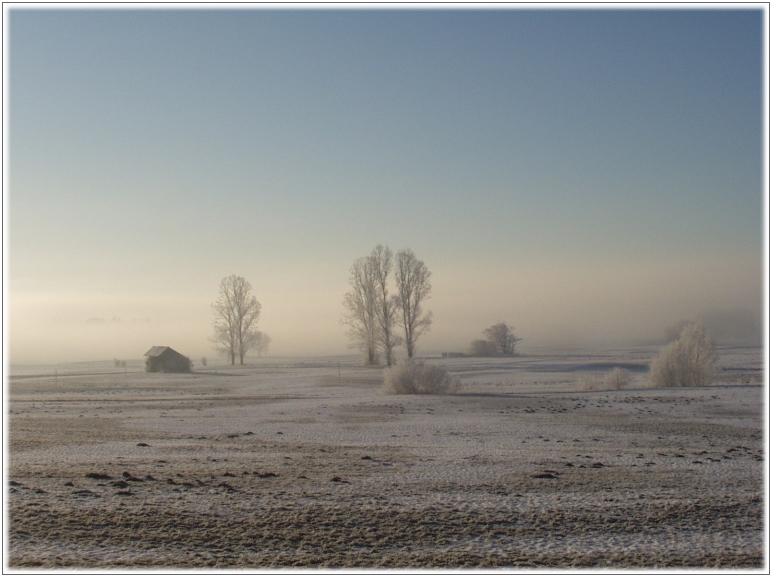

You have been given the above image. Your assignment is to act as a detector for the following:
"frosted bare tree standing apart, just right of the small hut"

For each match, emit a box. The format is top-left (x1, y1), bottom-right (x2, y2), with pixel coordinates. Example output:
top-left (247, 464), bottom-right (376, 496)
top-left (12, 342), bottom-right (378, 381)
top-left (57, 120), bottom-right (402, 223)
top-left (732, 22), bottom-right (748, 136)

top-left (212, 275), bottom-right (262, 365)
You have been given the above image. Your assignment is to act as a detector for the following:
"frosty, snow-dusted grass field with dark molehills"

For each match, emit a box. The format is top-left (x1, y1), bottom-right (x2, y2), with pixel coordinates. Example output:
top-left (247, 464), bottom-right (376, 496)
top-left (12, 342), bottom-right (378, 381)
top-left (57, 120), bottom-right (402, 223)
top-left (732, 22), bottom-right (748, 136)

top-left (5, 348), bottom-right (767, 571)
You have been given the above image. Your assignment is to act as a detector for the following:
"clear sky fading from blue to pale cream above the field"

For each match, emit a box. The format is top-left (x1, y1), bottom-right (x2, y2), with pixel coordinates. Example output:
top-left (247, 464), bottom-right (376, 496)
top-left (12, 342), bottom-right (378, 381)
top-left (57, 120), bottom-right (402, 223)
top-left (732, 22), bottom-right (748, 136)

top-left (3, 5), bottom-right (768, 364)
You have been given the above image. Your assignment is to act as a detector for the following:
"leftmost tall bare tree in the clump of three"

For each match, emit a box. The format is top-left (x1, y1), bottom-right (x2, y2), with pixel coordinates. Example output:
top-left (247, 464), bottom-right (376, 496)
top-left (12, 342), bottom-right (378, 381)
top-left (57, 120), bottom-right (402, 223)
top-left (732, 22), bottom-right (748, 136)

top-left (343, 257), bottom-right (378, 365)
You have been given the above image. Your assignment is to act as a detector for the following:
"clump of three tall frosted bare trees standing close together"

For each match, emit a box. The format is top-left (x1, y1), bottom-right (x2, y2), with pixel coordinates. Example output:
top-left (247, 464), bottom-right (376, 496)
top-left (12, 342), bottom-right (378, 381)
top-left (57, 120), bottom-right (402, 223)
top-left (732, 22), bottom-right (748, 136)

top-left (343, 244), bottom-right (432, 367)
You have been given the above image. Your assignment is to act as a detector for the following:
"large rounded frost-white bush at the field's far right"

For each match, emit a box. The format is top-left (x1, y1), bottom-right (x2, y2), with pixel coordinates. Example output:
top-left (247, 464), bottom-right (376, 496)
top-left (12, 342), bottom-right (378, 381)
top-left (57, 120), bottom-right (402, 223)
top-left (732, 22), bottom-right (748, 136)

top-left (649, 324), bottom-right (718, 387)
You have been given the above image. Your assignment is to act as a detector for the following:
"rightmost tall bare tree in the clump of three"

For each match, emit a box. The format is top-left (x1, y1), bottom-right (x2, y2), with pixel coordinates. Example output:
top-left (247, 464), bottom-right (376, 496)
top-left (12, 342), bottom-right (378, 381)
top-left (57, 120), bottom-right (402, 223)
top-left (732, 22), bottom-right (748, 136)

top-left (394, 249), bottom-right (432, 358)
